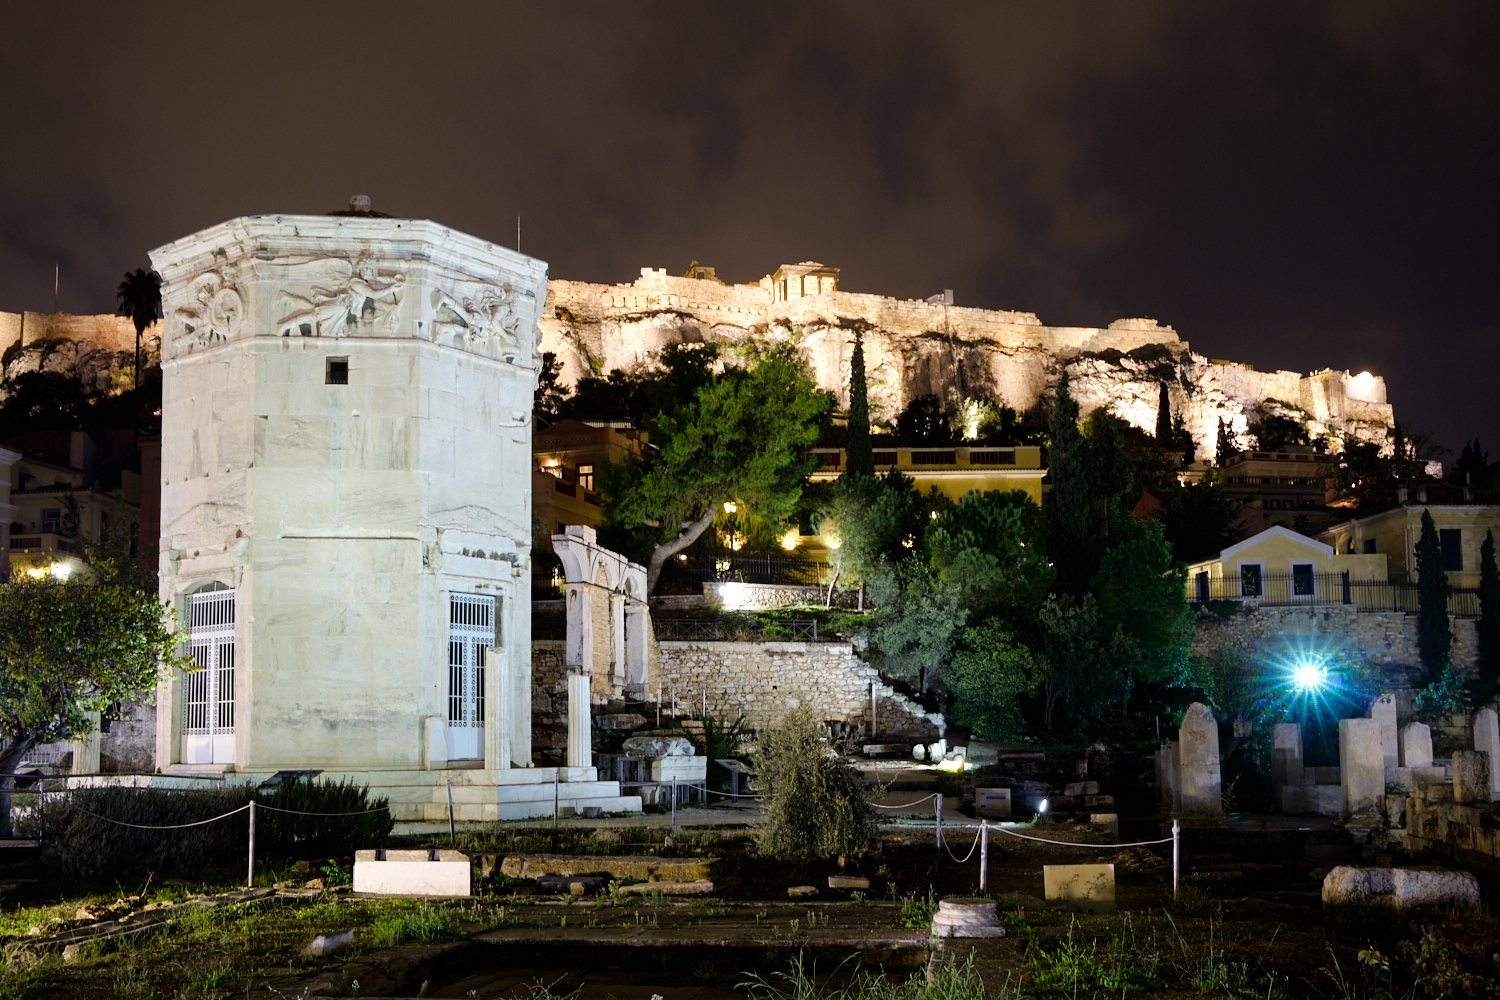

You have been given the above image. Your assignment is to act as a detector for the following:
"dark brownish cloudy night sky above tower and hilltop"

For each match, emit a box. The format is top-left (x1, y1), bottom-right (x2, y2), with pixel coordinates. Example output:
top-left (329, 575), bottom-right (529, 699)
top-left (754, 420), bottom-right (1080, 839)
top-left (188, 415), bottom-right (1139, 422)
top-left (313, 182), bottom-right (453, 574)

top-left (0, 0), bottom-right (1500, 457)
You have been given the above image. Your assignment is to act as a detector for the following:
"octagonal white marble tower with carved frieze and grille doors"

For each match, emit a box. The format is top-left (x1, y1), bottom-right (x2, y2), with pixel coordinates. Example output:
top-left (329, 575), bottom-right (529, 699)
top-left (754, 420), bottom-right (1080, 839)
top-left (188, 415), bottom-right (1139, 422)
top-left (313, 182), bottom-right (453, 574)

top-left (150, 216), bottom-right (567, 817)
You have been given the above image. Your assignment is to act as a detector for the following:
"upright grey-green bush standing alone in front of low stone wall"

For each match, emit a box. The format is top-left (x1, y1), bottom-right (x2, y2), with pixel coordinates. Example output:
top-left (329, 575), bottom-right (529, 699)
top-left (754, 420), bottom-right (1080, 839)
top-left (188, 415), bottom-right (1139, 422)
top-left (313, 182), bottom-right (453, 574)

top-left (752, 709), bottom-right (876, 861)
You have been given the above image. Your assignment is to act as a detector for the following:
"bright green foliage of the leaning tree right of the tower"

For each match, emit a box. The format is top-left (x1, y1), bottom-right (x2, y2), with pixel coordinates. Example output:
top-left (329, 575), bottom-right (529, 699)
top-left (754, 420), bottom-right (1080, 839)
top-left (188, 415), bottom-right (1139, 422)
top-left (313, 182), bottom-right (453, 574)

top-left (602, 348), bottom-right (833, 589)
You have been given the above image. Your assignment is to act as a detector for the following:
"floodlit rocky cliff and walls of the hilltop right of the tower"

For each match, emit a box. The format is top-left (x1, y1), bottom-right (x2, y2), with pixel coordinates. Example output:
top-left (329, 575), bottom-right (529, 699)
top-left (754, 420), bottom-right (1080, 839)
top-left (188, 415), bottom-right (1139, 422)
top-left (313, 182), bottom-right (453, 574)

top-left (539, 268), bottom-right (1394, 459)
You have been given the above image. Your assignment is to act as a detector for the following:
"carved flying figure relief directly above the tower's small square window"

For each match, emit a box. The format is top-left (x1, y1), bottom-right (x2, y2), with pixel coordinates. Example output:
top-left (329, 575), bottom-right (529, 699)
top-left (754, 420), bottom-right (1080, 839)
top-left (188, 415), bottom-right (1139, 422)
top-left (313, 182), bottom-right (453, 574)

top-left (276, 256), bottom-right (407, 337)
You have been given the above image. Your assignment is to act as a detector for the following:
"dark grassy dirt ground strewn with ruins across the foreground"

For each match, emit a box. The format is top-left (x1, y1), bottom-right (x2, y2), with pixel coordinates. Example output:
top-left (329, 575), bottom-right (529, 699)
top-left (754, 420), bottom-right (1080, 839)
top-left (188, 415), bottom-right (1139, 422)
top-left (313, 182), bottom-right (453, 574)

top-left (0, 828), bottom-right (1500, 1000)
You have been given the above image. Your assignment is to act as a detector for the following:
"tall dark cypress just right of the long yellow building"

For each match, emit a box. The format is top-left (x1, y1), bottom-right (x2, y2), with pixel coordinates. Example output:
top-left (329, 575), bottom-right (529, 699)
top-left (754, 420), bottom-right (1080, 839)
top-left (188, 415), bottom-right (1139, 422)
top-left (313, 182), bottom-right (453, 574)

top-left (1047, 372), bottom-right (1097, 597)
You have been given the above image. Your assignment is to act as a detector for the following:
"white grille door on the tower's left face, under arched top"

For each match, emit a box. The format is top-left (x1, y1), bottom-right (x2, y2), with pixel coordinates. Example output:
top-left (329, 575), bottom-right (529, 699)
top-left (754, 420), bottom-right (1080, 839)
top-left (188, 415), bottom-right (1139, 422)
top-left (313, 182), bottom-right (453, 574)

top-left (183, 591), bottom-right (234, 765)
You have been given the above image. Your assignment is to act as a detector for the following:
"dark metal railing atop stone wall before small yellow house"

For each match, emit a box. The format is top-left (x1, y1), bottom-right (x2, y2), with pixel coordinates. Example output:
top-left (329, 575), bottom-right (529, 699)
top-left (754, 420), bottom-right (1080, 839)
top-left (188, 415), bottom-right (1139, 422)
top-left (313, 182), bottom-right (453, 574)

top-left (1188, 570), bottom-right (1479, 618)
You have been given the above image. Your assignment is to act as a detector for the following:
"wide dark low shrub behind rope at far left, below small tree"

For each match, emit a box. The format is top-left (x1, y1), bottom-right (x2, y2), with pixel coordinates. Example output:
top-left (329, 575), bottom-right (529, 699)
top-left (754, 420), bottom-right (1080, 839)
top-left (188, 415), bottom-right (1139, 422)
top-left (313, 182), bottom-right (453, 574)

top-left (18, 786), bottom-right (254, 879)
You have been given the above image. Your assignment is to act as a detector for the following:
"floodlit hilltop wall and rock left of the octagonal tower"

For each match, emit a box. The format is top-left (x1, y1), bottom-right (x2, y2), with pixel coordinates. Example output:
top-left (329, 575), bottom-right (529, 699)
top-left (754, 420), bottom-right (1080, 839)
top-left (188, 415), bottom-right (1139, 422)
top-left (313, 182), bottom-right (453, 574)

top-left (0, 312), bottom-right (162, 391)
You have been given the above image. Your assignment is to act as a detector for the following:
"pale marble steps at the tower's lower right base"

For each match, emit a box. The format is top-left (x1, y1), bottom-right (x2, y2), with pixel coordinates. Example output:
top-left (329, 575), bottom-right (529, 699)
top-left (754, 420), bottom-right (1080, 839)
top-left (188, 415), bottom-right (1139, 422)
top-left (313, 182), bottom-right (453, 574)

top-left (423, 768), bottom-right (641, 823)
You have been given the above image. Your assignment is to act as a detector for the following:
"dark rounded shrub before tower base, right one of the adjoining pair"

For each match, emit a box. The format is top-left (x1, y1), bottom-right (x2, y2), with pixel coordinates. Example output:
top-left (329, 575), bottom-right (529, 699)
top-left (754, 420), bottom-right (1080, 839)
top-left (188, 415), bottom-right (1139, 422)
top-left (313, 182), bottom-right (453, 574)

top-left (255, 778), bottom-right (396, 858)
